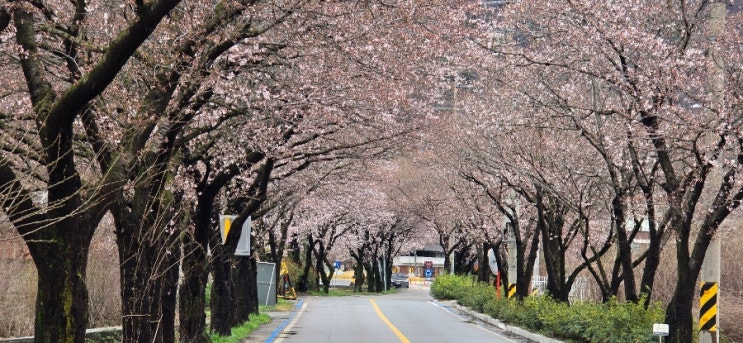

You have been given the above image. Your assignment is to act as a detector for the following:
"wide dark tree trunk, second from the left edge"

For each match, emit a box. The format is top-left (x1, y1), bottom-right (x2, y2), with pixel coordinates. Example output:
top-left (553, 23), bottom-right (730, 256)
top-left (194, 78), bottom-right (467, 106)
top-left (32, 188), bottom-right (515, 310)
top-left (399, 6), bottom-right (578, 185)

top-left (113, 177), bottom-right (181, 343)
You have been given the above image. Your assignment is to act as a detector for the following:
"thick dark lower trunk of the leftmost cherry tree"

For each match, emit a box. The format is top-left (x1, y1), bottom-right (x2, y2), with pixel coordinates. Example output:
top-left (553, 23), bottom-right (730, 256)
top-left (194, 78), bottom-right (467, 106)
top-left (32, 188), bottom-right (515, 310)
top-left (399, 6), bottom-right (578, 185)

top-left (0, 165), bottom-right (94, 342)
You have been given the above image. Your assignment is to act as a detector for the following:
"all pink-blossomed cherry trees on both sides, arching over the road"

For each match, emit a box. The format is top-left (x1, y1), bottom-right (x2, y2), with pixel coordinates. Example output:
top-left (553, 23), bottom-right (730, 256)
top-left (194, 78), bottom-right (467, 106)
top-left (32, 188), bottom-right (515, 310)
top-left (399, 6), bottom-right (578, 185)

top-left (0, 0), bottom-right (743, 342)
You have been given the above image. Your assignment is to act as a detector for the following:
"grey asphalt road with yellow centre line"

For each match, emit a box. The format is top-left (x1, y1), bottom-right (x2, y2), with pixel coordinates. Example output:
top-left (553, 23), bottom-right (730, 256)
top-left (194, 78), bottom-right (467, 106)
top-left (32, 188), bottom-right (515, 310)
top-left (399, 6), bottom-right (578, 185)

top-left (273, 287), bottom-right (516, 343)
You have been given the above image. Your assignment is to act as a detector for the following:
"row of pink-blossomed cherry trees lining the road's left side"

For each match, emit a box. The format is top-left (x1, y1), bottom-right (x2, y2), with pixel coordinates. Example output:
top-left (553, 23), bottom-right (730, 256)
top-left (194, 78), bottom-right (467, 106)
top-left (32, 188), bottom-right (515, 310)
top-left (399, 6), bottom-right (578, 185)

top-left (0, 0), bottom-right (471, 342)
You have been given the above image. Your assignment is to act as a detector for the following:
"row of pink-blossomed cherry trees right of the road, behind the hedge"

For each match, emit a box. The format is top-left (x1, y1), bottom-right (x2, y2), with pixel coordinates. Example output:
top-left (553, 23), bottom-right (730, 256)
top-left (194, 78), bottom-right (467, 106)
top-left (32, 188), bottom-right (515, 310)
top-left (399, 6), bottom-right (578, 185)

top-left (447, 1), bottom-right (743, 342)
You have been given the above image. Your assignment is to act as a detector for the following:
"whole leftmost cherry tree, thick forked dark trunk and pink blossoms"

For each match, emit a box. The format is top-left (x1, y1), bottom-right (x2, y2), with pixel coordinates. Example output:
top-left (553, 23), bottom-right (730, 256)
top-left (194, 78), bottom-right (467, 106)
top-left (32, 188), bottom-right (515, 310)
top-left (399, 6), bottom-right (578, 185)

top-left (0, 1), bottom-right (179, 342)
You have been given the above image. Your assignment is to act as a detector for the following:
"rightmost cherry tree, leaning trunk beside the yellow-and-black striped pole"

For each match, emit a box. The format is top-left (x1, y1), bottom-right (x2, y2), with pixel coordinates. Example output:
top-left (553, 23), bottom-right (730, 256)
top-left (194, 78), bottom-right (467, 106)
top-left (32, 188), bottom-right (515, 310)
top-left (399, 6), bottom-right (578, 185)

top-left (482, 1), bottom-right (741, 342)
